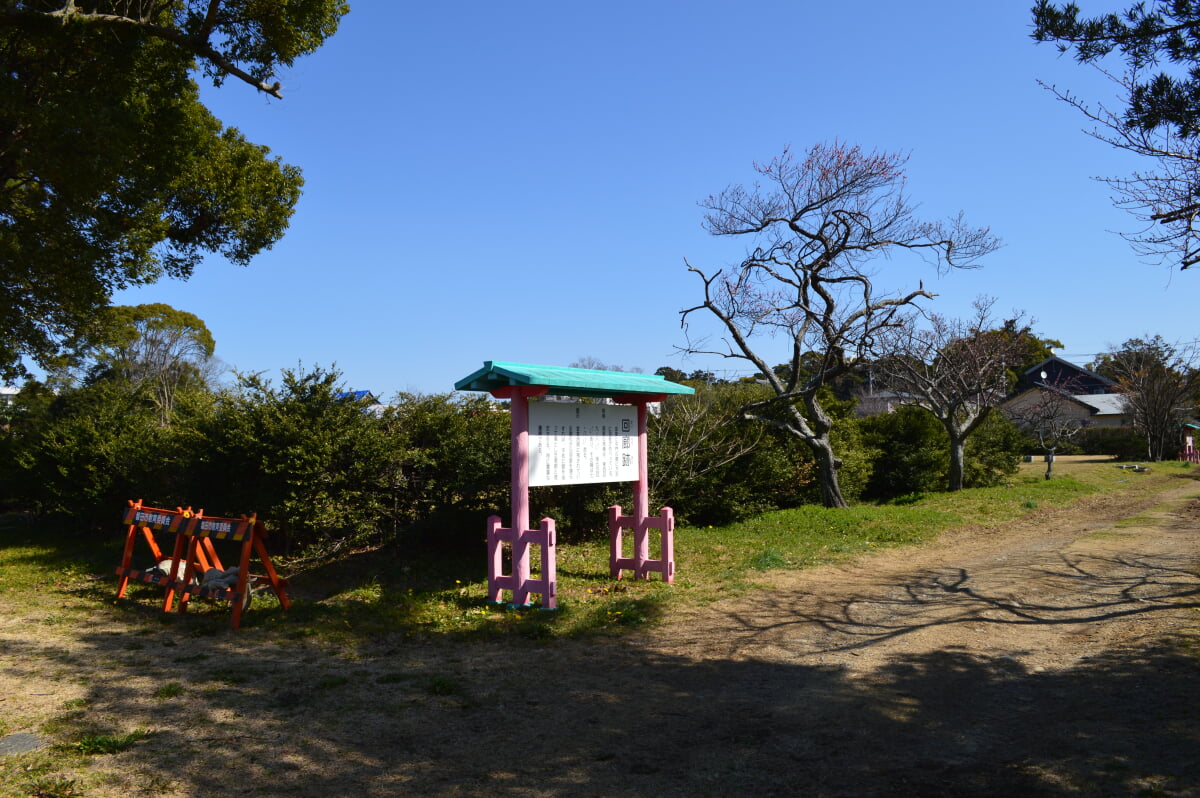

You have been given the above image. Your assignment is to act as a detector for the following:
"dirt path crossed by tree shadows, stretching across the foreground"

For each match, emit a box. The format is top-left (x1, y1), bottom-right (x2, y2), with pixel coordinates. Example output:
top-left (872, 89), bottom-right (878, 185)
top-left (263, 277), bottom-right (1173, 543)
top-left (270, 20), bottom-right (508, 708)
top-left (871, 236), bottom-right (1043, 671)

top-left (7, 480), bottom-right (1200, 798)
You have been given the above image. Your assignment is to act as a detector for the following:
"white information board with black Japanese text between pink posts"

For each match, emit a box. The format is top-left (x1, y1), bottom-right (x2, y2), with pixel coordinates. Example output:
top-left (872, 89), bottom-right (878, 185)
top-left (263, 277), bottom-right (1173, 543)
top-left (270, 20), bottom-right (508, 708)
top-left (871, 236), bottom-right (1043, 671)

top-left (529, 402), bottom-right (637, 485)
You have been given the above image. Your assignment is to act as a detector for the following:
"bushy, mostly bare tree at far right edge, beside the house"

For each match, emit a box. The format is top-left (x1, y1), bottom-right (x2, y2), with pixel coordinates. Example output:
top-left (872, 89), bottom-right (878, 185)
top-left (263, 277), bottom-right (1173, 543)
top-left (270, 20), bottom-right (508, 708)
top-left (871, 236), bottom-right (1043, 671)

top-left (1096, 335), bottom-right (1200, 461)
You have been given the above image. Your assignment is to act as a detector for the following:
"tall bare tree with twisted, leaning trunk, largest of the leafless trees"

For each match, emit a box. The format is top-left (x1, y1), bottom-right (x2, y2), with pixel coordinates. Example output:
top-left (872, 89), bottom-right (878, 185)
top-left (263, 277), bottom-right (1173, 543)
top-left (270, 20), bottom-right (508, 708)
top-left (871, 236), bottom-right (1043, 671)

top-left (682, 143), bottom-right (998, 508)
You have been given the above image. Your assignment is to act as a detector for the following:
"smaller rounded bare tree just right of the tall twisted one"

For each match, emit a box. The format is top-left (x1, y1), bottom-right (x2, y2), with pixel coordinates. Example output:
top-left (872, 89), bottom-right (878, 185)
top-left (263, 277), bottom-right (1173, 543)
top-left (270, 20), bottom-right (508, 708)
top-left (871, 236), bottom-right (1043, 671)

top-left (872, 296), bottom-right (1030, 491)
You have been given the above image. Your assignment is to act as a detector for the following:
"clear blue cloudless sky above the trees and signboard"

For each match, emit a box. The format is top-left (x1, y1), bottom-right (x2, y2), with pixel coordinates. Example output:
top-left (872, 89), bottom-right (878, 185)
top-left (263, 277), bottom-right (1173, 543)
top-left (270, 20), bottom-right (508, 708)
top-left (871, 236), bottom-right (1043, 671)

top-left (116, 0), bottom-right (1200, 398)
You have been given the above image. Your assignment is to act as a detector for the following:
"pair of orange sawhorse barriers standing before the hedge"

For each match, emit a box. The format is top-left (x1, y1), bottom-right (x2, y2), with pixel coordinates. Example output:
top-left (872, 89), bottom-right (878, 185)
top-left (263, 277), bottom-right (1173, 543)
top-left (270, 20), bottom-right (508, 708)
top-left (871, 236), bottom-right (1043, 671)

top-left (116, 500), bottom-right (292, 629)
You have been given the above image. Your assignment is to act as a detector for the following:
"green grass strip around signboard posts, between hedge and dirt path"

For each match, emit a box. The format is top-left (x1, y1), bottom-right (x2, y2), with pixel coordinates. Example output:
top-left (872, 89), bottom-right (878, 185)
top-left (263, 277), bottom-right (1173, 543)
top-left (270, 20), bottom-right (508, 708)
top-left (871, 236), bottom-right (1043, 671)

top-left (0, 461), bottom-right (1180, 647)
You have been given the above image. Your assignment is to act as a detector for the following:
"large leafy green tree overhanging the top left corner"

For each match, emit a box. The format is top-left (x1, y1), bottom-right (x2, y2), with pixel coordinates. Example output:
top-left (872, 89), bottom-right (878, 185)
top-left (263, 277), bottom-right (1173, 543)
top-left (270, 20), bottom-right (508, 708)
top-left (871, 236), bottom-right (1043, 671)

top-left (0, 0), bottom-right (346, 377)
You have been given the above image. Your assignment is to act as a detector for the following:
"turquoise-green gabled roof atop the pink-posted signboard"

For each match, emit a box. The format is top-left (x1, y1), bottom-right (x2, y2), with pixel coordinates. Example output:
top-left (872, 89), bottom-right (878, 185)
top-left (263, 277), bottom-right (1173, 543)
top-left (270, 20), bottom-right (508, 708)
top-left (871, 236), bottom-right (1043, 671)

top-left (454, 360), bottom-right (696, 397)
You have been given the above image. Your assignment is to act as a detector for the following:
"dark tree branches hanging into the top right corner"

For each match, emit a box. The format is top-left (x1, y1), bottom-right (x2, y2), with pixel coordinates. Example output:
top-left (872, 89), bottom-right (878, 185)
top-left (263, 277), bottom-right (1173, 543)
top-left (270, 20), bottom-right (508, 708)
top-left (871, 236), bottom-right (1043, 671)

top-left (1033, 0), bottom-right (1200, 269)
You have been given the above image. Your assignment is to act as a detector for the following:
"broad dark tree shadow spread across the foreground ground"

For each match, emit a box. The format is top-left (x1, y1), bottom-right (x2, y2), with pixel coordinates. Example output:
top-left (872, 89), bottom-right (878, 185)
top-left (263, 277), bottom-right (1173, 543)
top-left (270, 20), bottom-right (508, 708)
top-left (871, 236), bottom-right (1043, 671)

top-left (10, 609), bottom-right (1200, 797)
